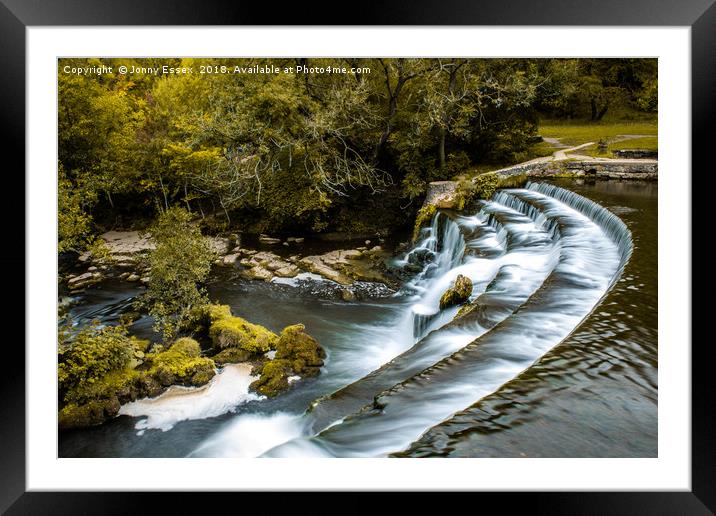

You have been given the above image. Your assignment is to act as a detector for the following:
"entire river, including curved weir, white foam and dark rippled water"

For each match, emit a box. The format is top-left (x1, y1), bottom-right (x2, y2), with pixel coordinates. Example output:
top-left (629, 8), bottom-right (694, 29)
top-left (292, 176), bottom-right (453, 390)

top-left (59, 180), bottom-right (657, 457)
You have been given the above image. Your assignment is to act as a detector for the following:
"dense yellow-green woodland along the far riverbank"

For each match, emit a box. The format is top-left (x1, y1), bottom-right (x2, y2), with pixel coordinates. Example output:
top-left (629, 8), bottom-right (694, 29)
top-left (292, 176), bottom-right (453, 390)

top-left (58, 58), bottom-right (657, 252)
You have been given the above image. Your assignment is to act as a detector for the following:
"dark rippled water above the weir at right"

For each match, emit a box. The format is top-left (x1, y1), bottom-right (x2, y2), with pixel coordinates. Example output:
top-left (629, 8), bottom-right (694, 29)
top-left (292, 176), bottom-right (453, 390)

top-left (396, 181), bottom-right (658, 457)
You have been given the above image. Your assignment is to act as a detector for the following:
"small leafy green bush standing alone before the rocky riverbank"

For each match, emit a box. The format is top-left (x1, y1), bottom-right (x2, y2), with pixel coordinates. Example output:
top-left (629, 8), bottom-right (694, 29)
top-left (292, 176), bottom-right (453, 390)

top-left (139, 208), bottom-right (214, 340)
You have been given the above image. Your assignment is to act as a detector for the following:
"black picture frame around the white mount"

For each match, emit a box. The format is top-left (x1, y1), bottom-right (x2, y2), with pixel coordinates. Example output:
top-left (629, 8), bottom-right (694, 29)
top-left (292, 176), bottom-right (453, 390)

top-left (0, 0), bottom-right (716, 515)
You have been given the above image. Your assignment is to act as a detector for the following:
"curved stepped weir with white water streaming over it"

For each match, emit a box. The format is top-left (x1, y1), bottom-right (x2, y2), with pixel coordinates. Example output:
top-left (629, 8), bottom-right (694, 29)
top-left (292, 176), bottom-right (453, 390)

top-left (192, 184), bottom-right (632, 457)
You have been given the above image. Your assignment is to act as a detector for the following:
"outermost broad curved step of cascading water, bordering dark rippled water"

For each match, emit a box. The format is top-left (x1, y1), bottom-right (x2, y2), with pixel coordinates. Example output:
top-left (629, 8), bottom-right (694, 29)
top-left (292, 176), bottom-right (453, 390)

top-left (256, 184), bottom-right (631, 457)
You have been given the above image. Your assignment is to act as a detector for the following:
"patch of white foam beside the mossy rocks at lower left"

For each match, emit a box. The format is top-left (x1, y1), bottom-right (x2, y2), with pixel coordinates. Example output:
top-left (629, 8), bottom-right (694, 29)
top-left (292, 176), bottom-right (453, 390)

top-left (119, 364), bottom-right (260, 435)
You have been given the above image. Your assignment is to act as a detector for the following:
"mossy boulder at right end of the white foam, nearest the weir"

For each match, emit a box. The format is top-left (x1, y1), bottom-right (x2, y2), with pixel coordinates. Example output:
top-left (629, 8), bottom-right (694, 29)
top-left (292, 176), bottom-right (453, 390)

top-left (249, 324), bottom-right (326, 398)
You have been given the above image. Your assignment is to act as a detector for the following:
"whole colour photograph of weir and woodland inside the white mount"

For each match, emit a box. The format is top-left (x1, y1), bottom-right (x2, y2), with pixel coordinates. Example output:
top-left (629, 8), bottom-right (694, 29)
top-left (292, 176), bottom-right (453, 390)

top-left (57, 57), bottom-right (660, 464)
